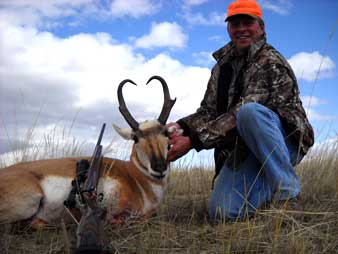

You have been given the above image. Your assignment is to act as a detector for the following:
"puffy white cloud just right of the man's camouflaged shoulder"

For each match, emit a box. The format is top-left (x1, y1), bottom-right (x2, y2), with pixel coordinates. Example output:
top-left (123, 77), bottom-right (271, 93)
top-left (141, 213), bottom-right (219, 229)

top-left (288, 51), bottom-right (336, 81)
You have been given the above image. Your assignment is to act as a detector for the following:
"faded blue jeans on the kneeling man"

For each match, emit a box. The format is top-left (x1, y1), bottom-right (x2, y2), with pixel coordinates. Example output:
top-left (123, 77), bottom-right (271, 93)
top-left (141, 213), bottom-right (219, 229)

top-left (208, 103), bottom-right (303, 220)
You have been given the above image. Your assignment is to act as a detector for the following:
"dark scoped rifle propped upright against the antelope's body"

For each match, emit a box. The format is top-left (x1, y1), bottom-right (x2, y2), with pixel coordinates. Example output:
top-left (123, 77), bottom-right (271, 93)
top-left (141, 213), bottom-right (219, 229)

top-left (75, 123), bottom-right (107, 254)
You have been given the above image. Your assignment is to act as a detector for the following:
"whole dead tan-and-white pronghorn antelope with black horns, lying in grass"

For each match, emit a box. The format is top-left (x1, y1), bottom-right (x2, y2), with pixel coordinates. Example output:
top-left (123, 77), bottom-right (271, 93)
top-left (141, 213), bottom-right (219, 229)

top-left (0, 76), bottom-right (176, 227)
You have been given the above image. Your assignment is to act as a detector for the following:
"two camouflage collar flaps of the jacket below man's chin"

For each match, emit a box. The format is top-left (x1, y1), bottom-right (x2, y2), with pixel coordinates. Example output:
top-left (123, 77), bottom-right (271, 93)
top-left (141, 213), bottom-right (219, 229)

top-left (212, 36), bottom-right (266, 63)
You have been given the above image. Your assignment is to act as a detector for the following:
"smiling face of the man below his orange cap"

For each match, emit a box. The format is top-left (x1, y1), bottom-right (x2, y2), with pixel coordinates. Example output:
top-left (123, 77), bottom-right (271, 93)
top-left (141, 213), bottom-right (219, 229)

top-left (228, 15), bottom-right (264, 52)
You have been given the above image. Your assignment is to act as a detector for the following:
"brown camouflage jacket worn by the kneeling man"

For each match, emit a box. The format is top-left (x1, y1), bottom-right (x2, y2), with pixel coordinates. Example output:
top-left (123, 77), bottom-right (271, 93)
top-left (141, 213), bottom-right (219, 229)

top-left (177, 37), bottom-right (314, 175)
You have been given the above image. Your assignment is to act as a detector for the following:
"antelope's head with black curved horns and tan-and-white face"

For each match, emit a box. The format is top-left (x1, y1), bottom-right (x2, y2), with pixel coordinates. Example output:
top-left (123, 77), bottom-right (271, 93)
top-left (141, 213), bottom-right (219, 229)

top-left (113, 76), bottom-right (176, 180)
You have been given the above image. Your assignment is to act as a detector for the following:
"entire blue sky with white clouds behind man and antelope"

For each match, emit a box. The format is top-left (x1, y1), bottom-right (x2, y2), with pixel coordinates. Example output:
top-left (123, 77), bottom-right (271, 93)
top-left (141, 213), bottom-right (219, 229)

top-left (0, 0), bottom-right (338, 166)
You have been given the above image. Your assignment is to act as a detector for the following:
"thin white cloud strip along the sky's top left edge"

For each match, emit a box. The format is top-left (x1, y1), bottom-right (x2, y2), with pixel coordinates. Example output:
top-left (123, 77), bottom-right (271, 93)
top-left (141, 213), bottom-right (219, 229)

top-left (0, 0), bottom-right (160, 29)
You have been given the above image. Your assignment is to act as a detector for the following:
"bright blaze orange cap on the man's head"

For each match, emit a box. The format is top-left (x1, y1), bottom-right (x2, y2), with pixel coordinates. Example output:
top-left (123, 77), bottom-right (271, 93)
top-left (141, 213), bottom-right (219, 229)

top-left (225, 0), bottom-right (262, 21)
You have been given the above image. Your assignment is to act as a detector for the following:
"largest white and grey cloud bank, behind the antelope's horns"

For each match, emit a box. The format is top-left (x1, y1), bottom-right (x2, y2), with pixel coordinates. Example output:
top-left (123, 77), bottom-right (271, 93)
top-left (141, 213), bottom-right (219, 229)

top-left (0, 18), bottom-right (210, 147)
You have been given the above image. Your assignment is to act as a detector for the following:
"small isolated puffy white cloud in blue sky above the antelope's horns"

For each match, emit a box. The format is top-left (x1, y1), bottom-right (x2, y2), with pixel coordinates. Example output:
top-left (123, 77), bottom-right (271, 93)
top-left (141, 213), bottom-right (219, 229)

top-left (135, 22), bottom-right (188, 48)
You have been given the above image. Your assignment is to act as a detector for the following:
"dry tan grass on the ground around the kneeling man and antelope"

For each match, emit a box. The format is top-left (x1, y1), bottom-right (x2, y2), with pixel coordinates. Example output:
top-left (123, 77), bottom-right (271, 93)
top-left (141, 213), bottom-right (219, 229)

top-left (0, 146), bottom-right (338, 254)
